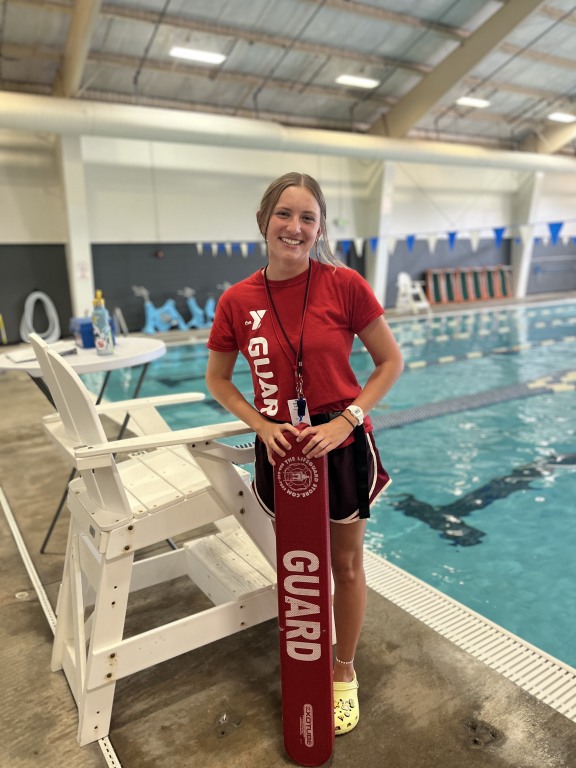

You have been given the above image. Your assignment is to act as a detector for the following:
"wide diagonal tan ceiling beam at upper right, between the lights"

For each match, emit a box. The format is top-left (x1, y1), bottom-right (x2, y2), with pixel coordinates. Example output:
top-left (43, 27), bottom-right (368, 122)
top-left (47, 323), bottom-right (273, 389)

top-left (370, 0), bottom-right (542, 138)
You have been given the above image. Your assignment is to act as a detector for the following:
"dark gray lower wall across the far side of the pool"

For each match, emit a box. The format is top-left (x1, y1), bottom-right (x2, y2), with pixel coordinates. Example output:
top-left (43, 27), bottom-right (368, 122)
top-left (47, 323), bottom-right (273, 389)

top-left (0, 239), bottom-right (576, 343)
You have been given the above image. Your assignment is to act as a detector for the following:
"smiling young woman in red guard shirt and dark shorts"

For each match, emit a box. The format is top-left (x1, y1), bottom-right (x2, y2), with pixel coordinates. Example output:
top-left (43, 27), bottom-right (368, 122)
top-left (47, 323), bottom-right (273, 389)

top-left (206, 173), bottom-right (403, 735)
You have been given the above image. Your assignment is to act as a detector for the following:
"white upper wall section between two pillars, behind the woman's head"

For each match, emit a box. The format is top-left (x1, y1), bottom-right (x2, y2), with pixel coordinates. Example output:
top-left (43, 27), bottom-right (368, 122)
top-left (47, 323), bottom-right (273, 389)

top-left (83, 138), bottom-right (374, 243)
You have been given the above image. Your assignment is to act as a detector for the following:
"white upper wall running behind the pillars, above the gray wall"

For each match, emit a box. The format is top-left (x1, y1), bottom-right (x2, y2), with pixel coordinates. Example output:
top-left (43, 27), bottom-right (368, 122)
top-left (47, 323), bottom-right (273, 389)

top-left (0, 127), bottom-right (576, 243)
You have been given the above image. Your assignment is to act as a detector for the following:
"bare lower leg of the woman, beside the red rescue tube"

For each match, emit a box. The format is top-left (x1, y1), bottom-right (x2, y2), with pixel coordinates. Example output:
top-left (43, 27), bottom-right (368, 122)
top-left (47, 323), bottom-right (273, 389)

top-left (330, 520), bottom-right (366, 683)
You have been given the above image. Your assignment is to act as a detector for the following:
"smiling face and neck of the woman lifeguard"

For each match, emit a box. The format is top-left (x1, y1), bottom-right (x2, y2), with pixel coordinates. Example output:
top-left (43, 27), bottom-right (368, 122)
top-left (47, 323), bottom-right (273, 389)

top-left (265, 187), bottom-right (320, 280)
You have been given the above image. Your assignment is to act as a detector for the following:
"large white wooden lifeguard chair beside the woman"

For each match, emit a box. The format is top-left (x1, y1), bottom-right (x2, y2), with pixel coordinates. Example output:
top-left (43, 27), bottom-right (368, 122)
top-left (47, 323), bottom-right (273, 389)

top-left (31, 344), bottom-right (278, 746)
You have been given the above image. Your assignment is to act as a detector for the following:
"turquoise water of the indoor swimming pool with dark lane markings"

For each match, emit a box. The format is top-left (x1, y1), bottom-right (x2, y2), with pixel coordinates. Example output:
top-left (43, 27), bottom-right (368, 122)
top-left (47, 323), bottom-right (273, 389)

top-left (83, 302), bottom-right (576, 666)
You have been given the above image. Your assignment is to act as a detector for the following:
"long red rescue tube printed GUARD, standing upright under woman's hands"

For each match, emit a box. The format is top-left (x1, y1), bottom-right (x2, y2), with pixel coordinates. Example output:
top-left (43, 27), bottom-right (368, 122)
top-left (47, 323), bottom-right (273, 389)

top-left (274, 426), bottom-right (334, 766)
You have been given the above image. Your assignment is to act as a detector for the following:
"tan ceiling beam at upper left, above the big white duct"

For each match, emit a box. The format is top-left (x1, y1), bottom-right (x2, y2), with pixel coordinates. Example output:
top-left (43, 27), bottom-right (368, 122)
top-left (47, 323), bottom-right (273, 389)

top-left (54, 0), bottom-right (102, 98)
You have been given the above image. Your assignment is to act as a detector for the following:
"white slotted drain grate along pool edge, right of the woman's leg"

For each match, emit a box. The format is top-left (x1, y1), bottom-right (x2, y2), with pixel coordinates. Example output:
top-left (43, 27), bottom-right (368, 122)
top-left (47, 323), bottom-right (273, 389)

top-left (364, 551), bottom-right (576, 722)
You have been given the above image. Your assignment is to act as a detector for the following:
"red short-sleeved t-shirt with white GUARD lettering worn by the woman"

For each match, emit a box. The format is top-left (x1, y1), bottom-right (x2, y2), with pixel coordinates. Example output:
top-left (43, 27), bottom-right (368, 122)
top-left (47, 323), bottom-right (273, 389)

top-left (207, 260), bottom-right (384, 429)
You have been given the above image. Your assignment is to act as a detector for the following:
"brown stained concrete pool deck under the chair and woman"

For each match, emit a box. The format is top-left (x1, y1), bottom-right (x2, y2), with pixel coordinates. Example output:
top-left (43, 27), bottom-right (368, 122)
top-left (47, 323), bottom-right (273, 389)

top-left (0, 296), bottom-right (576, 768)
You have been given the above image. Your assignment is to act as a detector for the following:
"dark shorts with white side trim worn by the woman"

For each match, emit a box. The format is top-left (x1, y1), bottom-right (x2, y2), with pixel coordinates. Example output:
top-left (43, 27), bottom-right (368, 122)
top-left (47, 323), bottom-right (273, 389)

top-left (252, 433), bottom-right (391, 523)
